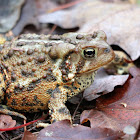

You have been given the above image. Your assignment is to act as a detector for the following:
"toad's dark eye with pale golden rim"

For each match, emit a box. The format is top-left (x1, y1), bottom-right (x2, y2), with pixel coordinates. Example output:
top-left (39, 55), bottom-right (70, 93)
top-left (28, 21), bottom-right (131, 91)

top-left (83, 48), bottom-right (96, 58)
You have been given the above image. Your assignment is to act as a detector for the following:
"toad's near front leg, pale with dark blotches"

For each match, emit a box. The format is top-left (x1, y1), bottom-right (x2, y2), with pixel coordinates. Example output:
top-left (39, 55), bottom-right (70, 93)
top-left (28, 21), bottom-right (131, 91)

top-left (48, 87), bottom-right (72, 123)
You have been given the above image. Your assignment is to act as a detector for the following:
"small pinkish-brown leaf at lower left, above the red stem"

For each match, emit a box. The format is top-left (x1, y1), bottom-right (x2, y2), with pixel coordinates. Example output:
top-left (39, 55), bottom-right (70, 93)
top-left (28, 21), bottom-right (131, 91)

top-left (0, 115), bottom-right (16, 129)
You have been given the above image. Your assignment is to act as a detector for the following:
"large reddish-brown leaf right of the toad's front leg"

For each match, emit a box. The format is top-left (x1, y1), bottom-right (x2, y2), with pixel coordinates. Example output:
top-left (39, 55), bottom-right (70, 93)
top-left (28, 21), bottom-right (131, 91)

top-left (81, 69), bottom-right (140, 131)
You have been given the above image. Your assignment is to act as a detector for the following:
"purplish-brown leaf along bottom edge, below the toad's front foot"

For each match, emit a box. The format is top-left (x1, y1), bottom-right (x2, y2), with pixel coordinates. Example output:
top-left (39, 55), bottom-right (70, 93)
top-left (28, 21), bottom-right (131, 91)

top-left (37, 120), bottom-right (123, 140)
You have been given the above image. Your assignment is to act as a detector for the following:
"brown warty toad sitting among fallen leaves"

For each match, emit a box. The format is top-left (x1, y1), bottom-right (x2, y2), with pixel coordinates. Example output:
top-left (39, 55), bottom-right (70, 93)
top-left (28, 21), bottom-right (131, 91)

top-left (0, 31), bottom-right (114, 122)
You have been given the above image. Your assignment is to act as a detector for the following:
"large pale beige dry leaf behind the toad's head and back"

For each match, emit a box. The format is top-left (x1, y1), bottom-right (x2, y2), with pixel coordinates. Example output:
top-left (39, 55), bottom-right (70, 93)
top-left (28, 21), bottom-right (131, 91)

top-left (38, 0), bottom-right (140, 60)
